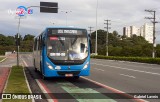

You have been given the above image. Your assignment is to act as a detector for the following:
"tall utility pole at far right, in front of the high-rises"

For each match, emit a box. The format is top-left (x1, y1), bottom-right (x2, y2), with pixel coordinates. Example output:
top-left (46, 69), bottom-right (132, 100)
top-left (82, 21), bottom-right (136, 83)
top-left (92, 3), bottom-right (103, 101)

top-left (145, 10), bottom-right (158, 58)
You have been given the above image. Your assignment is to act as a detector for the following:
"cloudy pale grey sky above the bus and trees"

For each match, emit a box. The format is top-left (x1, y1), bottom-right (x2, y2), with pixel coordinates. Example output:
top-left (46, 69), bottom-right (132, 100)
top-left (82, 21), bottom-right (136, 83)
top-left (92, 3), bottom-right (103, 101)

top-left (0, 0), bottom-right (160, 43)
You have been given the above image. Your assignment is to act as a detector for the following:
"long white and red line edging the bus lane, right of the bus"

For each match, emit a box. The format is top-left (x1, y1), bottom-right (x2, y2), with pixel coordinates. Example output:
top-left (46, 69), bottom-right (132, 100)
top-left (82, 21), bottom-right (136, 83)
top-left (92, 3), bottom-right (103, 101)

top-left (81, 76), bottom-right (149, 102)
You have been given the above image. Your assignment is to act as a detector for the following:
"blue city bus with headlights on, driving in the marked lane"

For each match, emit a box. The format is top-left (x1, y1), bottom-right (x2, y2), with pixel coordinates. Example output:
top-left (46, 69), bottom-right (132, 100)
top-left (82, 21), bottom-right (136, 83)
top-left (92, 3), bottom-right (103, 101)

top-left (33, 27), bottom-right (91, 79)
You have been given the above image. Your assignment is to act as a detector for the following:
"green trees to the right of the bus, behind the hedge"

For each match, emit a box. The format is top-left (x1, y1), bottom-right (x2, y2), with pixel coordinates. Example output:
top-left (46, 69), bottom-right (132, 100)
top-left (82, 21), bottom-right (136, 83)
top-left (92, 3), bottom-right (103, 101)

top-left (91, 30), bottom-right (160, 57)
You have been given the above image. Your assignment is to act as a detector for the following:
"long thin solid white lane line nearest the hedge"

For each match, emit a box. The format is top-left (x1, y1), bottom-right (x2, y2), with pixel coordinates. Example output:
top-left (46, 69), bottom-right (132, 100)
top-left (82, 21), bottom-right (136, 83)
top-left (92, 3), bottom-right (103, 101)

top-left (92, 63), bottom-right (160, 76)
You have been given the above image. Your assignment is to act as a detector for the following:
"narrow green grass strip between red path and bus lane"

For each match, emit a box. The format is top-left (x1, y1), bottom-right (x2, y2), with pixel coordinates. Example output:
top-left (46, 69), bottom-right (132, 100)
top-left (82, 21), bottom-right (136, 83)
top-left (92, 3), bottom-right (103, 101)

top-left (3, 66), bottom-right (32, 102)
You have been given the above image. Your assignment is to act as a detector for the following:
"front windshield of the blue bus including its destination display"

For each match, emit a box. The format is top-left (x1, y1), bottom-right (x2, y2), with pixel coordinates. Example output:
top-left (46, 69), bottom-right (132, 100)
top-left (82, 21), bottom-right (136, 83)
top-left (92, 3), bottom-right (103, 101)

top-left (47, 29), bottom-right (88, 60)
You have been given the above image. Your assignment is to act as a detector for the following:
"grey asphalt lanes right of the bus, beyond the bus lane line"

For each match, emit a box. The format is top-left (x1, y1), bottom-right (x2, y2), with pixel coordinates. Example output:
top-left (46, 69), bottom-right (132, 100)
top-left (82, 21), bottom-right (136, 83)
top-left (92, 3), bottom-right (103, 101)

top-left (89, 59), bottom-right (160, 93)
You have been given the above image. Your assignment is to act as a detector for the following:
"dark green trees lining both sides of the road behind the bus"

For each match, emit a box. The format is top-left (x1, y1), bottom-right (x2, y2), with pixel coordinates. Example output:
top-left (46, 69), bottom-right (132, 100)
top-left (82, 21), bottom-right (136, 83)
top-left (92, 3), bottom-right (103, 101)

top-left (0, 29), bottom-right (160, 58)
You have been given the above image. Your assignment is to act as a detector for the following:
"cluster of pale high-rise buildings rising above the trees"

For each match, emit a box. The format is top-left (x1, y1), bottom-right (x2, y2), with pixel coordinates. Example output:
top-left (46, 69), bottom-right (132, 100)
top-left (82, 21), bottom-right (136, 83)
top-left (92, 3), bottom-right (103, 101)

top-left (123, 23), bottom-right (153, 43)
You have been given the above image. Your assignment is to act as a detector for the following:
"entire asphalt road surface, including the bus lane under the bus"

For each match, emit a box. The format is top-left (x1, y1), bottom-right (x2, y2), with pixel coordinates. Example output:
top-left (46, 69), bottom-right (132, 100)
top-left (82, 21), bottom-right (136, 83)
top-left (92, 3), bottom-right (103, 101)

top-left (21, 55), bottom-right (160, 102)
